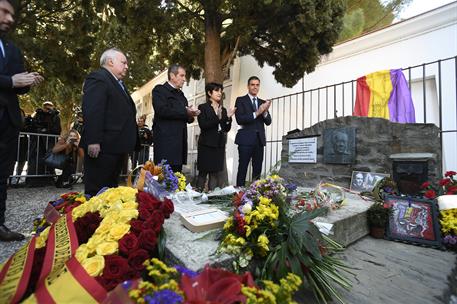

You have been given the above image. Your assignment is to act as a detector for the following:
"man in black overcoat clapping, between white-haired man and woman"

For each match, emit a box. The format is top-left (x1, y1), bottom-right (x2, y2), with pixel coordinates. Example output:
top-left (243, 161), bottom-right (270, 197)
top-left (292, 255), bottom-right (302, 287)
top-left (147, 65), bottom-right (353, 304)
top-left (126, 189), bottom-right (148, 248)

top-left (152, 64), bottom-right (200, 172)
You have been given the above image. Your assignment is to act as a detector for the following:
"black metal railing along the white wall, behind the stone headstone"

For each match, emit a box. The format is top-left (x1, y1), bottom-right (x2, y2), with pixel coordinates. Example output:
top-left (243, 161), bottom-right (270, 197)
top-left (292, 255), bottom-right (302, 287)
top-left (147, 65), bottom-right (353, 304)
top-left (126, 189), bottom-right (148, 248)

top-left (262, 56), bottom-right (457, 173)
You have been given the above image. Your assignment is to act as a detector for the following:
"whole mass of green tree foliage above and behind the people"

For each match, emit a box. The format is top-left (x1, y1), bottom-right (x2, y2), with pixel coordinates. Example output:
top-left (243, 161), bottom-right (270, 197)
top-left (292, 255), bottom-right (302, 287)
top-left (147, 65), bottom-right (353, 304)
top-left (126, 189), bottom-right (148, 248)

top-left (9, 0), bottom-right (344, 124)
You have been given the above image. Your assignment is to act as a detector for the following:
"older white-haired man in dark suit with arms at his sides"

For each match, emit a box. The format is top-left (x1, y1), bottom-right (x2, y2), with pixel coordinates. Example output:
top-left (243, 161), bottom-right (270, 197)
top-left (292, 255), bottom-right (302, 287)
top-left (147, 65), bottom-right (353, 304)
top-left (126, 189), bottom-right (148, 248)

top-left (80, 48), bottom-right (139, 195)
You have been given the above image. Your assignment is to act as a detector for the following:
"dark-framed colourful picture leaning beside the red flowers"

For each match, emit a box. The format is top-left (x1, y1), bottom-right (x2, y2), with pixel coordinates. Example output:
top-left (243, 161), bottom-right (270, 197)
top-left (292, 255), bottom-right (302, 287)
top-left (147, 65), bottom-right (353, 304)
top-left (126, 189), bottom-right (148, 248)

top-left (384, 195), bottom-right (441, 247)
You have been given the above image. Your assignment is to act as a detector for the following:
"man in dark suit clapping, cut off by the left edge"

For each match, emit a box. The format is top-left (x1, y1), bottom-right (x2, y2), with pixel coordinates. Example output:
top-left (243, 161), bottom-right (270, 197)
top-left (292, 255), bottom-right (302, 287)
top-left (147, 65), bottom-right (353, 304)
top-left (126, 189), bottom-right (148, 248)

top-left (0, 0), bottom-right (43, 242)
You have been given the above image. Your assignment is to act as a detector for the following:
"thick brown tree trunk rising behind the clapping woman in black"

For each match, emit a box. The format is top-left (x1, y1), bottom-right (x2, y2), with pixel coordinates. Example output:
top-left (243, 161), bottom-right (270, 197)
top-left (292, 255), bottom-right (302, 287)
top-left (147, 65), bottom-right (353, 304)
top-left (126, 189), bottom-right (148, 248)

top-left (204, 6), bottom-right (228, 185)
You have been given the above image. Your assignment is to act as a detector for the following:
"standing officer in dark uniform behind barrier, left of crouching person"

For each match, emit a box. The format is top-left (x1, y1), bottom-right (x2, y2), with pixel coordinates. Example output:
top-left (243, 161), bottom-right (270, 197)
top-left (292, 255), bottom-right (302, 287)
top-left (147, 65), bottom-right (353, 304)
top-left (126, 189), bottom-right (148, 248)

top-left (27, 101), bottom-right (62, 186)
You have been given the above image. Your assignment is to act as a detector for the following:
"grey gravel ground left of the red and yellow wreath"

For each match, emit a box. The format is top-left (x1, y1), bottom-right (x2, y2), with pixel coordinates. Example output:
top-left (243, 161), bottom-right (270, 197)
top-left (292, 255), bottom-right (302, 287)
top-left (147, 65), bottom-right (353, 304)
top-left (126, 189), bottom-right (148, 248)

top-left (0, 184), bottom-right (84, 264)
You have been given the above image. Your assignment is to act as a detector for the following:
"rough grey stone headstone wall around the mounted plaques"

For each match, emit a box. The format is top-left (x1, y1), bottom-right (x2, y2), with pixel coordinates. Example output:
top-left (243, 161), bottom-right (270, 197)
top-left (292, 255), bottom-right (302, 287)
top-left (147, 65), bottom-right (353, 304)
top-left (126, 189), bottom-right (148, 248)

top-left (279, 116), bottom-right (442, 187)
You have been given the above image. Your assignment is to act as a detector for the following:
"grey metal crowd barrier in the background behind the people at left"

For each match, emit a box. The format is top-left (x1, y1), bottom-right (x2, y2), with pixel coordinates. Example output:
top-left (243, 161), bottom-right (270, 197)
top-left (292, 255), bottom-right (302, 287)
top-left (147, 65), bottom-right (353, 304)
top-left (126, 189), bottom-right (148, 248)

top-left (9, 132), bottom-right (152, 185)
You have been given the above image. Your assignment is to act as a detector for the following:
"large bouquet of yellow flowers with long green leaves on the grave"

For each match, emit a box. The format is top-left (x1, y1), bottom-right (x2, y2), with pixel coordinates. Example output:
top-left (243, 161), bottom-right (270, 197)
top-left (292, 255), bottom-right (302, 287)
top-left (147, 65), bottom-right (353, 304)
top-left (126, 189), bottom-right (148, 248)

top-left (218, 174), bottom-right (351, 303)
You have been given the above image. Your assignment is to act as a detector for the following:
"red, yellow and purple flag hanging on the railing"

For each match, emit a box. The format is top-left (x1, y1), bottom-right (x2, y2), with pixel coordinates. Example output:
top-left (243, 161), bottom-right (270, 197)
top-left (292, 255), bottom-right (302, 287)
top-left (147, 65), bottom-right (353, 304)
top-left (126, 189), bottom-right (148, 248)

top-left (353, 69), bottom-right (416, 123)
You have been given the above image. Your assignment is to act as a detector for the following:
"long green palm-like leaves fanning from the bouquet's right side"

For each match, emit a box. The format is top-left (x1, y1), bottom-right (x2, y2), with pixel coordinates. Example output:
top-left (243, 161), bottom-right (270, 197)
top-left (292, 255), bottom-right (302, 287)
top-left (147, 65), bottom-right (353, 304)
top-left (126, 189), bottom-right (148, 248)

top-left (262, 208), bottom-right (351, 303)
